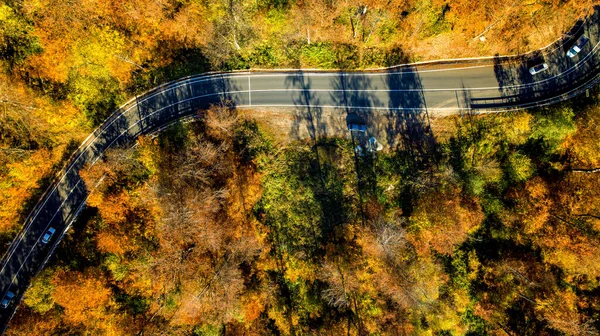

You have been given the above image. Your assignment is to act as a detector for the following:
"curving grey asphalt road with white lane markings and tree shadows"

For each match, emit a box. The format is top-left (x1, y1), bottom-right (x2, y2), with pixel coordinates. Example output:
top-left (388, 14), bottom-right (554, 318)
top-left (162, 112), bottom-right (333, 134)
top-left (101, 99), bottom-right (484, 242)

top-left (0, 7), bottom-right (600, 332)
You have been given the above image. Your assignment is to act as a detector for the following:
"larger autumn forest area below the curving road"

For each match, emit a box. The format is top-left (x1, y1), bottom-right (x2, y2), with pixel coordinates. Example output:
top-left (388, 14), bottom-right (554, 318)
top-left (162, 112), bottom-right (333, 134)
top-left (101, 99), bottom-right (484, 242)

top-left (8, 93), bottom-right (600, 335)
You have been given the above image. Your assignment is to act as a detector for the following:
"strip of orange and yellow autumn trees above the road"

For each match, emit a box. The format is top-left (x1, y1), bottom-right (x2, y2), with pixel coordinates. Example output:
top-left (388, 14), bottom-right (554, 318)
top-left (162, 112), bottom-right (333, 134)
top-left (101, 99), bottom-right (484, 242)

top-left (0, 0), bottom-right (591, 250)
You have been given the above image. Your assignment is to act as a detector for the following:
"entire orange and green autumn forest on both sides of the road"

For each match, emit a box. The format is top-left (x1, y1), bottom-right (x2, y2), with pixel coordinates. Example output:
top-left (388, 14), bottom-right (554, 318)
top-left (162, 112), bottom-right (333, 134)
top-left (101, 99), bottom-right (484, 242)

top-left (0, 0), bottom-right (600, 335)
